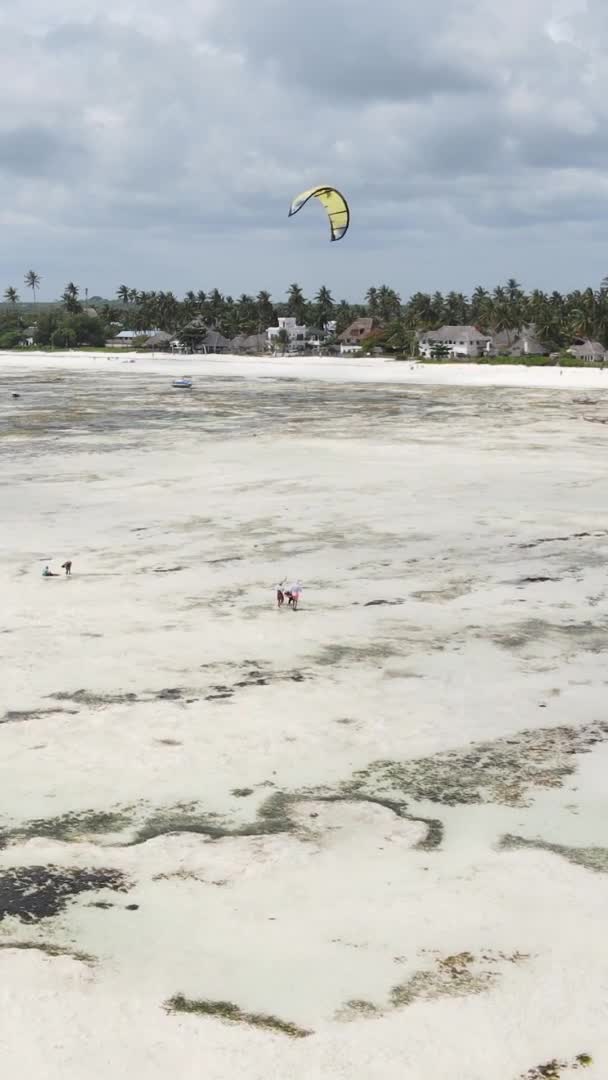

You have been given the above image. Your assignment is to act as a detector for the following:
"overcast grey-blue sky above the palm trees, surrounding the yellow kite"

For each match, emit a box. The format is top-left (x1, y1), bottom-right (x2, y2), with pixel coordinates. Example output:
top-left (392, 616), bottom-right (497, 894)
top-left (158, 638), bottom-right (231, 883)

top-left (0, 0), bottom-right (608, 299)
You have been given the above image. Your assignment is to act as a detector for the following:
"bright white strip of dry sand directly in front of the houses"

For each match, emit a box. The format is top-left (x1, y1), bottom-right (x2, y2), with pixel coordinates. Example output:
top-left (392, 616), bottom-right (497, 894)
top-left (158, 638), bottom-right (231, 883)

top-left (0, 350), bottom-right (608, 391)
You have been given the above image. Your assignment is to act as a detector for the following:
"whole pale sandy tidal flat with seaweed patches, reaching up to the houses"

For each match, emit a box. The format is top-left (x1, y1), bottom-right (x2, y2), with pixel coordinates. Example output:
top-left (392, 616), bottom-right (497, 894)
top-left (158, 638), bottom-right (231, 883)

top-left (0, 353), bottom-right (608, 1080)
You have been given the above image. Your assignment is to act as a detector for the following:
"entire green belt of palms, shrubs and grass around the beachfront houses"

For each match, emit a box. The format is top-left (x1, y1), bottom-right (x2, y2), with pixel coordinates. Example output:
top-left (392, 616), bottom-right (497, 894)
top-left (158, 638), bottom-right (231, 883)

top-left (0, 270), bottom-right (608, 354)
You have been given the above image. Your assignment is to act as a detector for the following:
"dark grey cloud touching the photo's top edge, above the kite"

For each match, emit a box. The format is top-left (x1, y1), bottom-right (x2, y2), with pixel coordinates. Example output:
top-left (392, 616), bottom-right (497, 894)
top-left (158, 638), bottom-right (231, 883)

top-left (212, 0), bottom-right (491, 105)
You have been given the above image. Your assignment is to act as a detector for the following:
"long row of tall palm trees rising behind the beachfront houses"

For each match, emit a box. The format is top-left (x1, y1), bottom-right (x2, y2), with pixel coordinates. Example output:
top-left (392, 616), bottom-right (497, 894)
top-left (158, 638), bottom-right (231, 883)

top-left (4, 270), bottom-right (608, 350)
